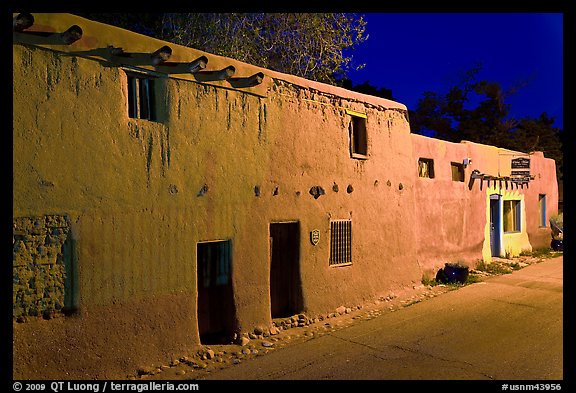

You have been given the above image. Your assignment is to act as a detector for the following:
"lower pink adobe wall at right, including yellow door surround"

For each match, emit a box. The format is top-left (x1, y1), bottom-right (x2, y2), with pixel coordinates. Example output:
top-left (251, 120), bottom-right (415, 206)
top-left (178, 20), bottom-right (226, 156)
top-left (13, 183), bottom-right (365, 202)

top-left (412, 135), bottom-right (558, 272)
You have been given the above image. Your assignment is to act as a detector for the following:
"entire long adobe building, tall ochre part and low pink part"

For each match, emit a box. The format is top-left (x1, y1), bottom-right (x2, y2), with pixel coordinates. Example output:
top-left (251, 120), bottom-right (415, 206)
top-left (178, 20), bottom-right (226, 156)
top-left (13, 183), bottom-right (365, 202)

top-left (13, 13), bottom-right (558, 379)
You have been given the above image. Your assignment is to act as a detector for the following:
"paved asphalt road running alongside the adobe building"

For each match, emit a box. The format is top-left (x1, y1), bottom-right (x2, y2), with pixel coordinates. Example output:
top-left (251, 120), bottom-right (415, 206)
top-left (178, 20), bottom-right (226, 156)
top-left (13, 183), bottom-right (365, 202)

top-left (203, 257), bottom-right (563, 380)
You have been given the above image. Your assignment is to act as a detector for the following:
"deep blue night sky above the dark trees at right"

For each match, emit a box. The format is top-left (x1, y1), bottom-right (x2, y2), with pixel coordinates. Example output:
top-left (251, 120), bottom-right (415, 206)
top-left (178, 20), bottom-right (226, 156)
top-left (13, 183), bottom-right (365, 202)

top-left (348, 13), bottom-right (563, 128)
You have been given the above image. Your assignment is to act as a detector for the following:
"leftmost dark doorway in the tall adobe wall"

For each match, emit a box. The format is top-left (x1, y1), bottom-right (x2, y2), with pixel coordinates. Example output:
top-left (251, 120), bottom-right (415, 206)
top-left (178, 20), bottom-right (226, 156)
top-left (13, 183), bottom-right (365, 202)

top-left (196, 240), bottom-right (236, 345)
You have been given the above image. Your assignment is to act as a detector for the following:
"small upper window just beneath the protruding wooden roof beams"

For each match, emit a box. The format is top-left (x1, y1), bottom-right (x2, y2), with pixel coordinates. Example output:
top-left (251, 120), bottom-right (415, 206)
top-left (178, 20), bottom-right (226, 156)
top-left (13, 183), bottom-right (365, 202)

top-left (127, 74), bottom-right (156, 121)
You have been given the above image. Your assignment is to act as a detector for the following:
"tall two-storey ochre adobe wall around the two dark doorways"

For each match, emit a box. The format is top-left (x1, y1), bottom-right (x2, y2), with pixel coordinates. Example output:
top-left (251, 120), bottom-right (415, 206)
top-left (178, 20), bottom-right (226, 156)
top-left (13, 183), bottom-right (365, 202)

top-left (13, 16), bottom-right (420, 379)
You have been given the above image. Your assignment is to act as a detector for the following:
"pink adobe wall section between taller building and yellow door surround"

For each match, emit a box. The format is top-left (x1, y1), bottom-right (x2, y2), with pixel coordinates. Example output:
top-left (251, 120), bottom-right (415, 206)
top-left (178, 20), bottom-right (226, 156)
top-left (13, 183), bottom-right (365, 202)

top-left (411, 134), bottom-right (486, 278)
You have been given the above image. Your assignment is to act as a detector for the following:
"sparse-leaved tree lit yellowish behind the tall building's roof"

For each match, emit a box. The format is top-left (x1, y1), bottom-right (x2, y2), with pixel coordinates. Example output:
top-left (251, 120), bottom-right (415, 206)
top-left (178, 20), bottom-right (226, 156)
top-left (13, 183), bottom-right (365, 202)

top-left (76, 13), bottom-right (368, 84)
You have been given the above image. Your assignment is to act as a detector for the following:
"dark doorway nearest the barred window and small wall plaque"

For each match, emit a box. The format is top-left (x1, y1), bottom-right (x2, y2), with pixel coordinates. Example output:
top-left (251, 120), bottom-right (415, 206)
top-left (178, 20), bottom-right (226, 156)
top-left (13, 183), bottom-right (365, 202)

top-left (270, 222), bottom-right (303, 318)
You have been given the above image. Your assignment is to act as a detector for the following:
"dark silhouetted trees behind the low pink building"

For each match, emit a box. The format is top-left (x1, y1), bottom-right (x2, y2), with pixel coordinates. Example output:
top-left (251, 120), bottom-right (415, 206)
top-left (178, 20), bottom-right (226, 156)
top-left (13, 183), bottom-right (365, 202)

top-left (410, 66), bottom-right (563, 179)
